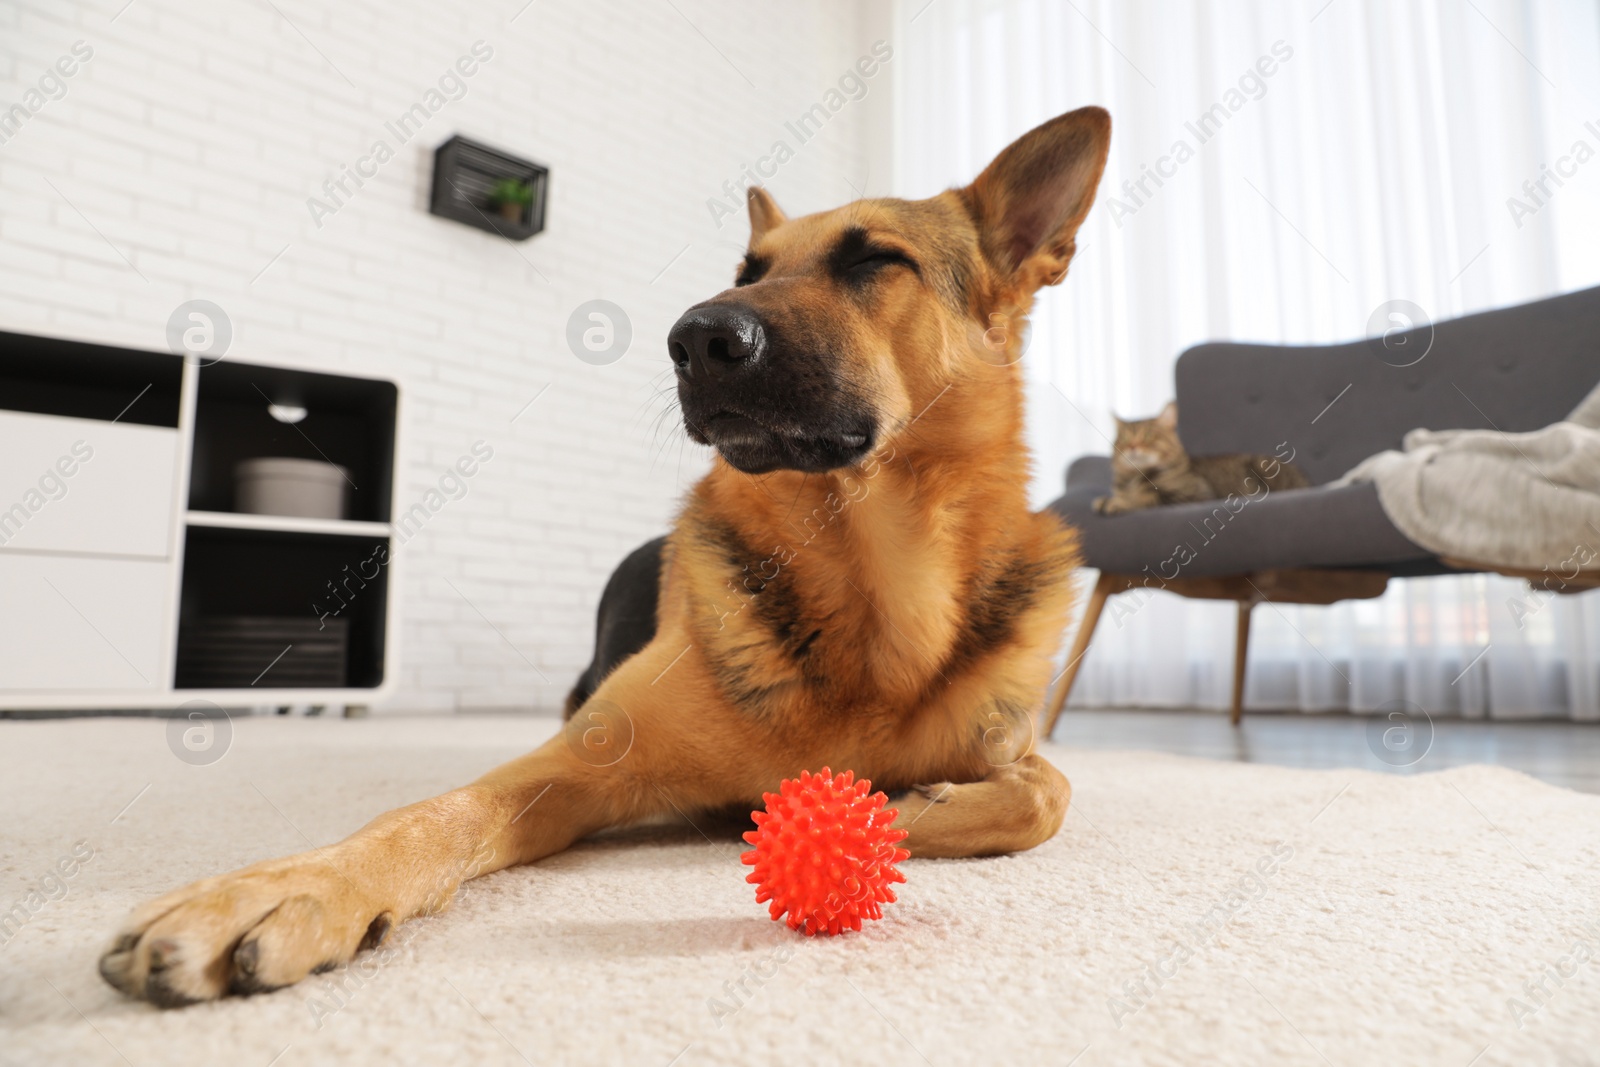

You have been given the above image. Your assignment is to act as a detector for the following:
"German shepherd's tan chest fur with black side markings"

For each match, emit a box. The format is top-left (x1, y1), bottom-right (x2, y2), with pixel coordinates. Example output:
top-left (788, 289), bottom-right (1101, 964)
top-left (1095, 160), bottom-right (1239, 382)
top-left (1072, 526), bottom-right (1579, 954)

top-left (678, 463), bottom-right (1075, 721)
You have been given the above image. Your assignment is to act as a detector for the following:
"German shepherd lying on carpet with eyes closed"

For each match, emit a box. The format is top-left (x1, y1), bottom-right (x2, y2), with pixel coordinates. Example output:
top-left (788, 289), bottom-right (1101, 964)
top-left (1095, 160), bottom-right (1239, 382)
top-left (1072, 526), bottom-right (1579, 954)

top-left (99, 107), bottom-right (1110, 1006)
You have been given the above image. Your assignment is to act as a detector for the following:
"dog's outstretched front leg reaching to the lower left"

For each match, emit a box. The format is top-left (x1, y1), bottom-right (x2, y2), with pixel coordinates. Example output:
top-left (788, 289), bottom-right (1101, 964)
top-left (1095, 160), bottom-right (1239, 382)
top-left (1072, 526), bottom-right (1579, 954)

top-left (99, 632), bottom-right (748, 1006)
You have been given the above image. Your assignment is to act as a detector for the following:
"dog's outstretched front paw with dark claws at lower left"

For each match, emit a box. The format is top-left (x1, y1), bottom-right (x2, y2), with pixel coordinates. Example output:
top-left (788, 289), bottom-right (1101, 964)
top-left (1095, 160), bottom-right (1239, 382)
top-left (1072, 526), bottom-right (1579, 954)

top-left (99, 849), bottom-right (394, 1008)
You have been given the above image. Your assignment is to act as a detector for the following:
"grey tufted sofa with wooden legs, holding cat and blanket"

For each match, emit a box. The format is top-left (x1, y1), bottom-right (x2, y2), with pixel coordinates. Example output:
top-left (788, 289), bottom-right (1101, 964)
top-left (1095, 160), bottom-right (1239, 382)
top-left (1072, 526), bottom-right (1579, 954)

top-left (1043, 288), bottom-right (1600, 736)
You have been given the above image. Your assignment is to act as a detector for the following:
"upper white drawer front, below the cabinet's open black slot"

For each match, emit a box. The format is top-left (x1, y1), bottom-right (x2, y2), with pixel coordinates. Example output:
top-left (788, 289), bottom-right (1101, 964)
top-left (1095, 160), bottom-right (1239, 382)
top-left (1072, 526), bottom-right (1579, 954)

top-left (0, 411), bottom-right (178, 558)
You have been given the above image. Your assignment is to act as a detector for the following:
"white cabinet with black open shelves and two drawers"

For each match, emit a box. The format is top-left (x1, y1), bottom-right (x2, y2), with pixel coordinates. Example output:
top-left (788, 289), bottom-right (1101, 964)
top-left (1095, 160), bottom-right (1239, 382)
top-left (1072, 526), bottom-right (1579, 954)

top-left (0, 333), bottom-right (400, 710)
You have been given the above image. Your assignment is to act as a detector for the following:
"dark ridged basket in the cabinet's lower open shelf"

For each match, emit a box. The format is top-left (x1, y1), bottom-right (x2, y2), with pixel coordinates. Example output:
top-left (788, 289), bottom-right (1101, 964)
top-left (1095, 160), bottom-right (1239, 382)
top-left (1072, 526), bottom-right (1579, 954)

top-left (178, 616), bottom-right (350, 689)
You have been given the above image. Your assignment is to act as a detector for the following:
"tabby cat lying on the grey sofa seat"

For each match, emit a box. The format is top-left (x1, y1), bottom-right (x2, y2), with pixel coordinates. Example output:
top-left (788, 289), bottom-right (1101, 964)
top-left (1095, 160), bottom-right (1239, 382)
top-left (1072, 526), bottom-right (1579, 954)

top-left (1094, 403), bottom-right (1310, 515)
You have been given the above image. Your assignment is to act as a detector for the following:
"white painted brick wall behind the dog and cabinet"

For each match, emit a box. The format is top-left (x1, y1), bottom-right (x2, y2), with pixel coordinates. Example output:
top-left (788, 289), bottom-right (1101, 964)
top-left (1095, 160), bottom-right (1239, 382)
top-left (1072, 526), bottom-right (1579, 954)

top-left (0, 0), bottom-right (893, 709)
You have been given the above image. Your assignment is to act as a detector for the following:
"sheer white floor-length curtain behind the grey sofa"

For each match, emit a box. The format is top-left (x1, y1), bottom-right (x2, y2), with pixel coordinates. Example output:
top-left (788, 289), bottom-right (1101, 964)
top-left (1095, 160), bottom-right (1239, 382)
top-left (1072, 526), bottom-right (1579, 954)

top-left (893, 0), bottom-right (1600, 720)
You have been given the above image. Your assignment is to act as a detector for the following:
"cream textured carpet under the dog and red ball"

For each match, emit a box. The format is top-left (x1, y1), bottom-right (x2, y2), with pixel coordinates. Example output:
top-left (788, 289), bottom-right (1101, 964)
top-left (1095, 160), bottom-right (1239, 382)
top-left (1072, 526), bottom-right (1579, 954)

top-left (0, 718), bottom-right (1600, 1067)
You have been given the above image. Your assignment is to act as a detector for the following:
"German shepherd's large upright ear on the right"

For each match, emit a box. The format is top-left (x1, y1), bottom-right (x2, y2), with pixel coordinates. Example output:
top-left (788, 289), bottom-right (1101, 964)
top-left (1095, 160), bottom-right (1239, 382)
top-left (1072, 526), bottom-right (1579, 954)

top-left (960, 107), bottom-right (1110, 288)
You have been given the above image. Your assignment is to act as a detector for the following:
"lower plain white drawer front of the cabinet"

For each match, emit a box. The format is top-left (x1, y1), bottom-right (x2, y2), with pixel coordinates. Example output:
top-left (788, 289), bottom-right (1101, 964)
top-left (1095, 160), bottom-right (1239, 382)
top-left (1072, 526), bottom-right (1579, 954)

top-left (0, 550), bottom-right (173, 694)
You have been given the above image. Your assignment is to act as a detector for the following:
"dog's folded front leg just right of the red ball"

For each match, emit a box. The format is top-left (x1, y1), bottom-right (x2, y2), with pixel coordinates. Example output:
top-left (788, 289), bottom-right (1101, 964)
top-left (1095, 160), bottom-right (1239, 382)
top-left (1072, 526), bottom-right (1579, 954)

top-left (893, 752), bottom-right (1072, 857)
